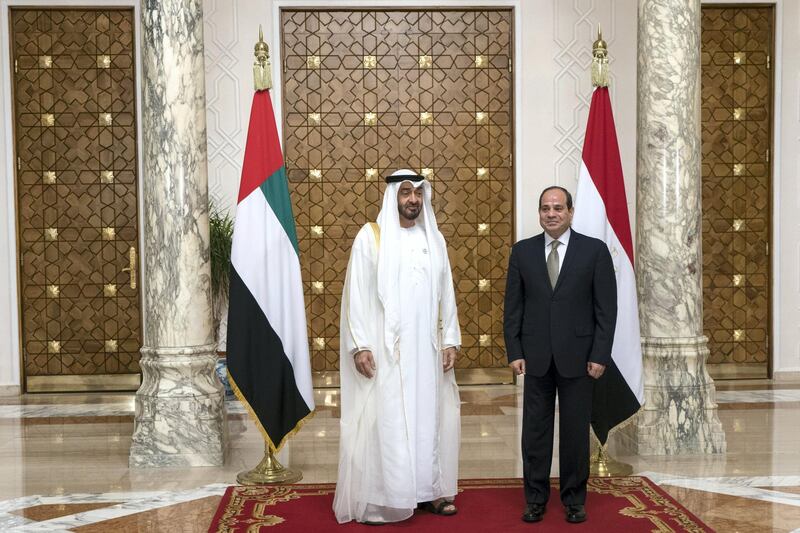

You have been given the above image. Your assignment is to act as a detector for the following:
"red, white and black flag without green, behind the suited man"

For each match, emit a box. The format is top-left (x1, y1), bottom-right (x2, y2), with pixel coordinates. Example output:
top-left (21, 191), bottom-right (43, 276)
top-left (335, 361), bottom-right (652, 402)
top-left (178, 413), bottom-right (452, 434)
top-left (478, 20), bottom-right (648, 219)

top-left (572, 87), bottom-right (644, 444)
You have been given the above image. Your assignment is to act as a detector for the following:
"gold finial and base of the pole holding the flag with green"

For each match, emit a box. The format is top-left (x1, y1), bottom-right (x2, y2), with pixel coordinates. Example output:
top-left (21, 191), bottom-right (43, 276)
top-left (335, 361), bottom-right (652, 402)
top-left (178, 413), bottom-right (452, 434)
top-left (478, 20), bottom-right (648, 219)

top-left (236, 29), bottom-right (303, 485)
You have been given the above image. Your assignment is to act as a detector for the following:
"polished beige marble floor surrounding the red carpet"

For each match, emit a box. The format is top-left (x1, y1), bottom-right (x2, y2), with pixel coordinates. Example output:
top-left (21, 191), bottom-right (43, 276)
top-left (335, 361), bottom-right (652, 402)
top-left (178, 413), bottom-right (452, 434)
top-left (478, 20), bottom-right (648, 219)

top-left (0, 380), bottom-right (800, 533)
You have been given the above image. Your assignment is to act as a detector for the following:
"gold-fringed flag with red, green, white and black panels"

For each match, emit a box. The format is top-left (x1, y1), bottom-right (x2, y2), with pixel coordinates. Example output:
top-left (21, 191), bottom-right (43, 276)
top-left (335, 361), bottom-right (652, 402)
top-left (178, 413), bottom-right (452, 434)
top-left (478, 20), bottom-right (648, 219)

top-left (227, 91), bottom-right (314, 453)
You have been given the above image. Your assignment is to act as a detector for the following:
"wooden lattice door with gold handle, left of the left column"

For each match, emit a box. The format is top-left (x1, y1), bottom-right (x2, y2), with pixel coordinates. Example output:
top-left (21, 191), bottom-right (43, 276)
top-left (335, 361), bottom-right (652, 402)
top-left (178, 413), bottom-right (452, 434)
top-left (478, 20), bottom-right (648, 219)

top-left (11, 9), bottom-right (141, 377)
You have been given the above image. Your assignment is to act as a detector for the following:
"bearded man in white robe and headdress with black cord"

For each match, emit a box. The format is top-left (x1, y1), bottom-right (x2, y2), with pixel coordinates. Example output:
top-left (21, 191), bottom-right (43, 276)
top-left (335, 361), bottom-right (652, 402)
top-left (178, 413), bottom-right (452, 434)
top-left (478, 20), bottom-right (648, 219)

top-left (333, 170), bottom-right (461, 524)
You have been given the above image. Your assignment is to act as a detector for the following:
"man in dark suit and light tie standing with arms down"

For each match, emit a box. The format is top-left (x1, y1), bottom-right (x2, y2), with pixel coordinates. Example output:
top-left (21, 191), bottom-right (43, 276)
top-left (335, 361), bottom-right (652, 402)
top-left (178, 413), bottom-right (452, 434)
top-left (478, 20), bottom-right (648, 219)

top-left (503, 187), bottom-right (617, 523)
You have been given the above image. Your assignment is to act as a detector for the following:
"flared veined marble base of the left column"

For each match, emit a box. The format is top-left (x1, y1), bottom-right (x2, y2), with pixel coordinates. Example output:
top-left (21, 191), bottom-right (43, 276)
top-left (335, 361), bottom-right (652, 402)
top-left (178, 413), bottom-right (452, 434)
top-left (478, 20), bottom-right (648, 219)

top-left (129, 344), bottom-right (228, 468)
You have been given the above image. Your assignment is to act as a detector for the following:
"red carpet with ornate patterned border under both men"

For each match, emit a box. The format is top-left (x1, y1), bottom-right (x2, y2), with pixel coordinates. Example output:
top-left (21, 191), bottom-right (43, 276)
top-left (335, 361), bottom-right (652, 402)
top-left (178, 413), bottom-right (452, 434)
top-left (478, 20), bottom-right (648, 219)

top-left (209, 477), bottom-right (713, 533)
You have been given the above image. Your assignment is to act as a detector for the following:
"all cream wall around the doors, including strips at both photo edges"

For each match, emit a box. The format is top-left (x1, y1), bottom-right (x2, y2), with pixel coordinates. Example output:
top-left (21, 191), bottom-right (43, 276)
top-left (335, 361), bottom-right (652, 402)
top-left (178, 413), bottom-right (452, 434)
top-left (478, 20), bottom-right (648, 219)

top-left (0, 0), bottom-right (800, 385)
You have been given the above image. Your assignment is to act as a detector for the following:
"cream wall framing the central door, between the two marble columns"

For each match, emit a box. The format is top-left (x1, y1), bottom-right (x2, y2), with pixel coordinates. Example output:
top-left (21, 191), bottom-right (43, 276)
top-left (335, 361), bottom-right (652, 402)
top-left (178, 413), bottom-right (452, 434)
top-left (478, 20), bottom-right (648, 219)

top-left (204, 0), bottom-right (636, 233)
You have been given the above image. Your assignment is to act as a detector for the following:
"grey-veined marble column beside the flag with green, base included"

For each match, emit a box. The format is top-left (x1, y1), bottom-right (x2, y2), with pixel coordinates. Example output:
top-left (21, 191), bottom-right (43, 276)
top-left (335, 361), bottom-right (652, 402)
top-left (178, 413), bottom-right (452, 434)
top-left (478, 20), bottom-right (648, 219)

top-left (130, 0), bottom-right (227, 467)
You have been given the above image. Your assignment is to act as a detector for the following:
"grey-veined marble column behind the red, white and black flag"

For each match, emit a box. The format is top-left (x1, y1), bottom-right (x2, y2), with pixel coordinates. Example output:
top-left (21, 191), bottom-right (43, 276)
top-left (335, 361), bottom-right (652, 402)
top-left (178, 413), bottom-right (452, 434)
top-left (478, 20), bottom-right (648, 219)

top-left (636, 0), bottom-right (725, 454)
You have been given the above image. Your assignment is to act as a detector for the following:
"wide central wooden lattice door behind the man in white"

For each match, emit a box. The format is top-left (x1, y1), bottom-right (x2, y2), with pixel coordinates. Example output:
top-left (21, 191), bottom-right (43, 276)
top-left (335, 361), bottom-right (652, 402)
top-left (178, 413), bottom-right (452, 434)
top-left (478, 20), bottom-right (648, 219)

top-left (281, 9), bottom-right (514, 371)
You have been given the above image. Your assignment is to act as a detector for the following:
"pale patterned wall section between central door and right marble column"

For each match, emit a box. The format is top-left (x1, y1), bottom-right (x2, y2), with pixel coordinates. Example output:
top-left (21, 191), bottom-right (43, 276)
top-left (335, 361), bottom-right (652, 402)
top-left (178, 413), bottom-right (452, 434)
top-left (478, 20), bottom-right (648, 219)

top-left (515, 0), bottom-right (636, 238)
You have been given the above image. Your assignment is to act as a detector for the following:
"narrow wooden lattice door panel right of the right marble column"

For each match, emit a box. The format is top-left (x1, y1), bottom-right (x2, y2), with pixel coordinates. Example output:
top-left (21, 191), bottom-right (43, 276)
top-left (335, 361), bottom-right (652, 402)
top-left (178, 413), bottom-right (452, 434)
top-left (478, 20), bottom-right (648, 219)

top-left (702, 7), bottom-right (774, 375)
